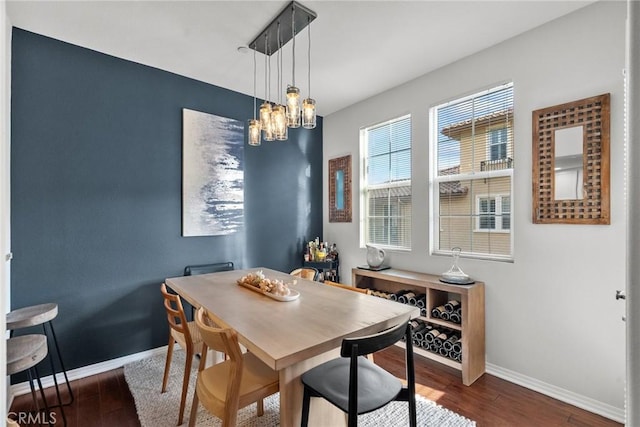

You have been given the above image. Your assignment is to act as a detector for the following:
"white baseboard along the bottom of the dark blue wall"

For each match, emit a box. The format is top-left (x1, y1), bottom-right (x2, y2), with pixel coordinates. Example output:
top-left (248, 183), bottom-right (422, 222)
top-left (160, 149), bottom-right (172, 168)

top-left (7, 345), bottom-right (167, 402)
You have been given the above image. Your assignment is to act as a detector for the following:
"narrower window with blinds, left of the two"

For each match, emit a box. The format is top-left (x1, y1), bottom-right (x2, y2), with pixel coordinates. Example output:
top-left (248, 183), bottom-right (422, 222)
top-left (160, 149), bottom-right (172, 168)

top-left (361, 116), bottom-right (411, 249)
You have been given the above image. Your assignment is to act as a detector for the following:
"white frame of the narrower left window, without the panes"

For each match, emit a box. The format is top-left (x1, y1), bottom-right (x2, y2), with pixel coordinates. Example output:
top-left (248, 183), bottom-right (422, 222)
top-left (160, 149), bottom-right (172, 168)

top-left (359, 113), bottom-right (414, 252)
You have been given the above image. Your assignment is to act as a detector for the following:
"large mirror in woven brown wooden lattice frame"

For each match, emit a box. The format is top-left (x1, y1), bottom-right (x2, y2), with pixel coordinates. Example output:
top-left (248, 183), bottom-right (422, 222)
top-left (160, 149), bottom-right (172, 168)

top-left (533, 93), bottom-right (611, 224)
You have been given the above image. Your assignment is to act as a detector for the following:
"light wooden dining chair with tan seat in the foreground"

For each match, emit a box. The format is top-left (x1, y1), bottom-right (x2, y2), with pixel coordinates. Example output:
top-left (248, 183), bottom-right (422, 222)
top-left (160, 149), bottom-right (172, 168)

top-left (189, 307), bottom-right (280, 427)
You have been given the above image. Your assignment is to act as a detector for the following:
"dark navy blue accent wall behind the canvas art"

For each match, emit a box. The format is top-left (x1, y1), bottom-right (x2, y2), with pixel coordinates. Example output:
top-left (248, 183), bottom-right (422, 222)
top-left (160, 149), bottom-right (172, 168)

top-left (11, 28), bottom-right (322, 369)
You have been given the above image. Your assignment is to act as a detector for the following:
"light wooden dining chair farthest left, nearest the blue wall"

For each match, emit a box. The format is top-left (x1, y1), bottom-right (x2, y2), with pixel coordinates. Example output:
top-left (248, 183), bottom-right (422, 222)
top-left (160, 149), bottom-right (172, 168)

top-left (160, 283), bottom-right (203, 425)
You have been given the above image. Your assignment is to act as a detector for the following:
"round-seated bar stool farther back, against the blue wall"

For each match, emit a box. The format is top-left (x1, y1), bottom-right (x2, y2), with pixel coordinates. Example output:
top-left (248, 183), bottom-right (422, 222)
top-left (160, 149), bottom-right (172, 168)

top-left (7, 303), bottom-right (74, 405)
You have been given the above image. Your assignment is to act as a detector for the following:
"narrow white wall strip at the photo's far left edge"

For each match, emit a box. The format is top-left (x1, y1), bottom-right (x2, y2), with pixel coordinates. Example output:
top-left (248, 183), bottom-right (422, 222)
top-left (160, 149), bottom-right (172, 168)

top-left (0, 0), bottom-right (11, 422)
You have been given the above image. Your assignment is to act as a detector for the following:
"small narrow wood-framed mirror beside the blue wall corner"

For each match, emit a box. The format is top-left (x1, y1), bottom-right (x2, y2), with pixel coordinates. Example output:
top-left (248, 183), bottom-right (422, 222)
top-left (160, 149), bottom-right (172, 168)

top-left (329, 154), bottom-right (351, 222)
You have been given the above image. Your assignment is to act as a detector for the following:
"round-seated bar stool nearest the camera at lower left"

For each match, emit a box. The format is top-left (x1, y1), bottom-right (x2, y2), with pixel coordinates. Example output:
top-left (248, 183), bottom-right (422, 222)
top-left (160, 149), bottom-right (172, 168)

top-left (7, 334), bottom-right (67, 426)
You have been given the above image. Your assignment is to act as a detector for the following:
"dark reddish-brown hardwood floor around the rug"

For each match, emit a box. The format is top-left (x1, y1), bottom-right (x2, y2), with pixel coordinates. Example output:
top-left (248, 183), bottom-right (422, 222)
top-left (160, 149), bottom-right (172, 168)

top-left (11, 347), bottom-right (622, 427)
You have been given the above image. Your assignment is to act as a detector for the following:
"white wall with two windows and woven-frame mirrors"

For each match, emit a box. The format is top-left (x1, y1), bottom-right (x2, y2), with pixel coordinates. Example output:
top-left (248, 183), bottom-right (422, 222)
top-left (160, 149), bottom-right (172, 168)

top-left (319, 2), bottom-right (626, 420)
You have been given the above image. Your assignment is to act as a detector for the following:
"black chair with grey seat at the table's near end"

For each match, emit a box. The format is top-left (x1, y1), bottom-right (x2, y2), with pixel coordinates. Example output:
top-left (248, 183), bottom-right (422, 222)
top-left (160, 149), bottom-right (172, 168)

top-left (301, 320), bottom-right (416, 427)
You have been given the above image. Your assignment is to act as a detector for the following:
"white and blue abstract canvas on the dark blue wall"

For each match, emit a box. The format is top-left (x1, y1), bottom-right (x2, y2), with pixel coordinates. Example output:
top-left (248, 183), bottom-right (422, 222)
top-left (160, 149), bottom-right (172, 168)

top-left (182, 108), bottom-right (244, 236)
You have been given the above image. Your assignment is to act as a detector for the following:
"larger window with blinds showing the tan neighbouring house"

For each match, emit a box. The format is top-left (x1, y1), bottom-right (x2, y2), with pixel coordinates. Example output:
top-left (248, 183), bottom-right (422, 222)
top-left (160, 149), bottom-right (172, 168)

top-left (431, 83), bottom-right (514, 260)
